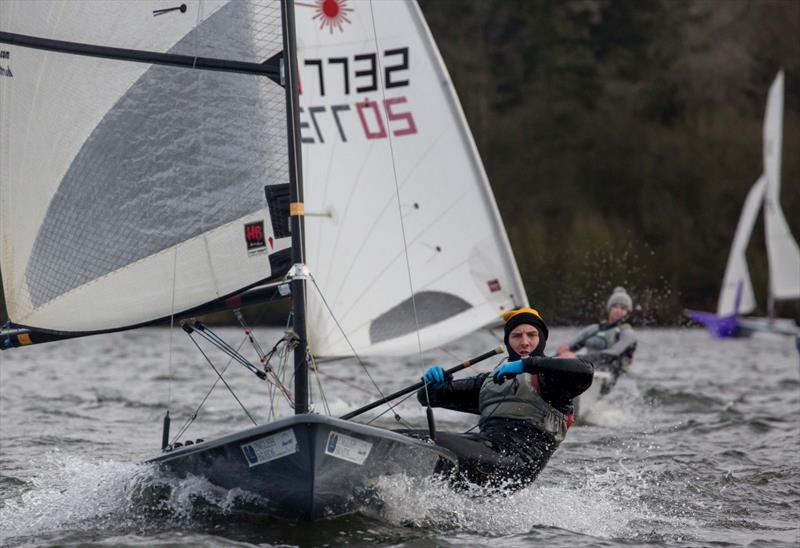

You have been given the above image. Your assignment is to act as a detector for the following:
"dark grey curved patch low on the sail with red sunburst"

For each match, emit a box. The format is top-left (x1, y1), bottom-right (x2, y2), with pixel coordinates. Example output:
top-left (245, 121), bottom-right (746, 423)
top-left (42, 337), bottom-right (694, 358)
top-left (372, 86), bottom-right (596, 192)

top-left (369, 291), bottom-right (470, 344)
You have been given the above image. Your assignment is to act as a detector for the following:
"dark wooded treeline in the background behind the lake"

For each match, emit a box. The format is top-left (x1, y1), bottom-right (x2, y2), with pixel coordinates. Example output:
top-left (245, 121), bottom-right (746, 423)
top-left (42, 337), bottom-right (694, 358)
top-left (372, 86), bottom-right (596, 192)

top-left (0, 0), bottom-right (800, 325)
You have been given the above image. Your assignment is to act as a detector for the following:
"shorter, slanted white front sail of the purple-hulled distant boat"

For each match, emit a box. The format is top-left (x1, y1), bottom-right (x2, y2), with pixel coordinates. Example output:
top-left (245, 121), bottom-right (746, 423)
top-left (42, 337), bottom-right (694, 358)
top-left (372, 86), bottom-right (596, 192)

top-left (717, 175), bottom-right (767, 316)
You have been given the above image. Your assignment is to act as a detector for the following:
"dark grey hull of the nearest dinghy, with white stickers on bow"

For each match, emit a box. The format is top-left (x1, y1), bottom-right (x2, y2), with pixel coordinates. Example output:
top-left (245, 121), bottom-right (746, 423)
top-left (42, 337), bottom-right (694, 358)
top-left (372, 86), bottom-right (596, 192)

top-left (147, 414), bottom-right (456, 521)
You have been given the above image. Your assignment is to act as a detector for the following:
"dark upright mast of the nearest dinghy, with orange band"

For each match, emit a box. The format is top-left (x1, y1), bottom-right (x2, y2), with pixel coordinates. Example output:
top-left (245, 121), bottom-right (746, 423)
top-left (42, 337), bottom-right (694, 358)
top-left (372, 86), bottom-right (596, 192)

top-left (281, 0), bottom-right (308, 415)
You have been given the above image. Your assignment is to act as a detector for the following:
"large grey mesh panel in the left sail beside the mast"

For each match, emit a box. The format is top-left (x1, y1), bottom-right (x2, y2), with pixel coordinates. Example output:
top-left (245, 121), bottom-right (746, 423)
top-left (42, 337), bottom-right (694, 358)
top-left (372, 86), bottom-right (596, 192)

top-left (26, 2), bottom-right (288, 307)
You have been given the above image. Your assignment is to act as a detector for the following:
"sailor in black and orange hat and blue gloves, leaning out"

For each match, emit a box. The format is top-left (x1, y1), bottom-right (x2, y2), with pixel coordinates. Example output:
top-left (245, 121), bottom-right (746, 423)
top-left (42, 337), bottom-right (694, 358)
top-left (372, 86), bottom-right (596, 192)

top-left (417, 308), bottom-right (593, 488)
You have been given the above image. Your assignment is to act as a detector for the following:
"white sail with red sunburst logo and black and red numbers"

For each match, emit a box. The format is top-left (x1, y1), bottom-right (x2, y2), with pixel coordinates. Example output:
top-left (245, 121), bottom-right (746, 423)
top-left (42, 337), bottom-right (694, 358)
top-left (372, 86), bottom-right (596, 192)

top-left (295, 0), bottom-right (527, 355)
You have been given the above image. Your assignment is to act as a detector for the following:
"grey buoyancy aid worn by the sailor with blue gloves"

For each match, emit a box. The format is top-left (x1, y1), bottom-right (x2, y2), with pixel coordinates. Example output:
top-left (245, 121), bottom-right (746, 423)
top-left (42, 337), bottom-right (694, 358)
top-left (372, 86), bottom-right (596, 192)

top-left (478, 373), bottom-right (572, 443)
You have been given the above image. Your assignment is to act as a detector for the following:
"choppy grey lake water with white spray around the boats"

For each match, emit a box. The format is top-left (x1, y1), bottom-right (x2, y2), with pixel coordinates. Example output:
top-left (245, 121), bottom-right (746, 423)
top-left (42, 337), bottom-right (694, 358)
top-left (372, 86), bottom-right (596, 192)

top-left (0, 329), bottom-right (800, 547)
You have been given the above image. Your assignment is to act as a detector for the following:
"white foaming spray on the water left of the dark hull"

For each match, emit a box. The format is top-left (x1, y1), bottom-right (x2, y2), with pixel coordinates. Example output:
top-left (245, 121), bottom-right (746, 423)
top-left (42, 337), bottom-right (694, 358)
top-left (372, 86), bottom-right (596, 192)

top-left (0, 450), bottom-right (272, 539)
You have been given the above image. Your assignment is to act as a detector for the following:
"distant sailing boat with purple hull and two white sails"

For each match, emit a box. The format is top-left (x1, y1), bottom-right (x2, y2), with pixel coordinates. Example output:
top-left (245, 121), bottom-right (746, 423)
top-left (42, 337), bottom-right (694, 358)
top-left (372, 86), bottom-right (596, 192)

top-left (687, 71), bottom-right (800, 337)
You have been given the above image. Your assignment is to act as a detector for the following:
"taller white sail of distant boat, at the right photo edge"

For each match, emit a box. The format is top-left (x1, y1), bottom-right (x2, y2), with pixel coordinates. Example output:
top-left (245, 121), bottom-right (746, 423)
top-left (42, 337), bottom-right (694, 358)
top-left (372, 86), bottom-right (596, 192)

top-left (764, 71), bottom-right (800, 299)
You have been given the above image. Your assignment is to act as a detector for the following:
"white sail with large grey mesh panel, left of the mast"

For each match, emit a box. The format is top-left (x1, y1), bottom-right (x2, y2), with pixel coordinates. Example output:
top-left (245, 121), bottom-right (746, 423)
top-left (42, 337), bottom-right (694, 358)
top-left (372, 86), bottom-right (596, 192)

top-left (0, 0), bottom-right (290, 332)
